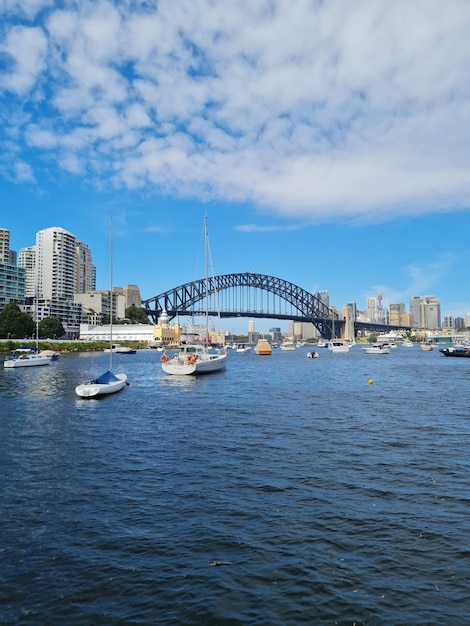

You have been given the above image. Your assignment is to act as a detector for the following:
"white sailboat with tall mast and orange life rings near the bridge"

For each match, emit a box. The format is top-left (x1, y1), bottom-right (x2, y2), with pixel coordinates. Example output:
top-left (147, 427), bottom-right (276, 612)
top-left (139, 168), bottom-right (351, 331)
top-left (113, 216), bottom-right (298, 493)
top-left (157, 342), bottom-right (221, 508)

top-left (160, 215), bottom-right (227, 376)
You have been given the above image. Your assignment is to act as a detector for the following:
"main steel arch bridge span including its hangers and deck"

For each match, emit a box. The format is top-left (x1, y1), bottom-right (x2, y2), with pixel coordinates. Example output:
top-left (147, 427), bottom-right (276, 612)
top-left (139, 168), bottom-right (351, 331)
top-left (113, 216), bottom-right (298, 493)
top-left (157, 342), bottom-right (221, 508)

top-left (142, 272), bottom-right (344, 339)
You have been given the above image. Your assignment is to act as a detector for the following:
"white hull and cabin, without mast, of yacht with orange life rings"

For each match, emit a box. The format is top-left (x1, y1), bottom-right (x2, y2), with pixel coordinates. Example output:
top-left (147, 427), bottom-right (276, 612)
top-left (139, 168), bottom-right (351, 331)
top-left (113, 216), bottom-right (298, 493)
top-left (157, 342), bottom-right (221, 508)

top-left (160, 343), bottom-right (227, 376)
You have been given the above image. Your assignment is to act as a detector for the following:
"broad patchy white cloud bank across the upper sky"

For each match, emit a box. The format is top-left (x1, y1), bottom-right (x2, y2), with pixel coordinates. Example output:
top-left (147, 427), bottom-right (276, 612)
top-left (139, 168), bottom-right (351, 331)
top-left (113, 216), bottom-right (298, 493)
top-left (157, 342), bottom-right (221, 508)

top-left (1, 0), bottom-right (470, 221)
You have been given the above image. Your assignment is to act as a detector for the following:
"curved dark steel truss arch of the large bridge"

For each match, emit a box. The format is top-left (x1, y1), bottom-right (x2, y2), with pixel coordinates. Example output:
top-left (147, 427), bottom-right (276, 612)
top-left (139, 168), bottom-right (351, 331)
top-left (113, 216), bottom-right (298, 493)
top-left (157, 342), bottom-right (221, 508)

top-left (142, 272), bottom-right (343, 339)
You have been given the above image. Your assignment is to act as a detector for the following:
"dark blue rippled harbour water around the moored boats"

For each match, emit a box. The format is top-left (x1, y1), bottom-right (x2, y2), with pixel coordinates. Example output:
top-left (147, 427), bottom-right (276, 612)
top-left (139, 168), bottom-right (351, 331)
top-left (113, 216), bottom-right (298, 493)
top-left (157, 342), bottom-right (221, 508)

top-left (0, 346), bottom-right (470, 626)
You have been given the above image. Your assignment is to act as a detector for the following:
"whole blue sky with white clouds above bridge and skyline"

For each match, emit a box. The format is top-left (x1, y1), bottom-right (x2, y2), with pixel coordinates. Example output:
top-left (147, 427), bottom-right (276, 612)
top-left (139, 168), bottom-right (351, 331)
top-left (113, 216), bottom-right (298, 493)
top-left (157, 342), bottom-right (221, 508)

top-left (0, 0), bottom-right (470, 327)
